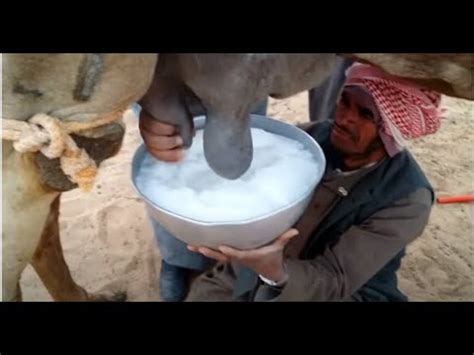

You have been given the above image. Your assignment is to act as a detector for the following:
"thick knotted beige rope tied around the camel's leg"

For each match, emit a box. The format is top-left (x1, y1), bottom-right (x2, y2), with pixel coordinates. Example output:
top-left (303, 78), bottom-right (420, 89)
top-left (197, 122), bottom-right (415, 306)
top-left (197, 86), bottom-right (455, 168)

top-left (2, 110), bottom-right (125, 191)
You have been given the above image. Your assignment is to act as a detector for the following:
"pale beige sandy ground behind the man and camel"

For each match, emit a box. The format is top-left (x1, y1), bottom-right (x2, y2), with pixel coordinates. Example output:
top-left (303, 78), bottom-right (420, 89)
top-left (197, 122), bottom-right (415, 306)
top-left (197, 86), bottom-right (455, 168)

top-left (21, 93), bottom-right (474, 301)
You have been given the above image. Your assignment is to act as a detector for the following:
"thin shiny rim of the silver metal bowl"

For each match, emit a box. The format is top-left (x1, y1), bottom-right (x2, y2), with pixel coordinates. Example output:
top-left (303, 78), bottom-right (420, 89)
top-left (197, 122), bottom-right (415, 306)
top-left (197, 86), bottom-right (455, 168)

top-left (131, 114), bottom-right (326, 227)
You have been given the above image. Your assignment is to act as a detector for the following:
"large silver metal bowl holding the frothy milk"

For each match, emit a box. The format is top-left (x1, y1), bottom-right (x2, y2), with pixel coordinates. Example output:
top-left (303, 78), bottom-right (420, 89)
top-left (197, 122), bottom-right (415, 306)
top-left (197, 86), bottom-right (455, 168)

top-left (132, 115), bottom-right (326, 249)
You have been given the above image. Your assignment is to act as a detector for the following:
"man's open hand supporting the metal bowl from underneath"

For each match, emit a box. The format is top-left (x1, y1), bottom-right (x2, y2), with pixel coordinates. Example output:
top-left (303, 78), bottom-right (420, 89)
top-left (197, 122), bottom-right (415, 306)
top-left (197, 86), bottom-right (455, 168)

top-left (188, 229), bottom-right (299, 282)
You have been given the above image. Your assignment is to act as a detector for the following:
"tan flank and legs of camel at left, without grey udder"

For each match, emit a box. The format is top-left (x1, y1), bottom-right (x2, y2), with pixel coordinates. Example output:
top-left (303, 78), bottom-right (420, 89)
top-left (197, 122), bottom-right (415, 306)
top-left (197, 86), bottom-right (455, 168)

top-left (2, 54), bottom-right (157, 301)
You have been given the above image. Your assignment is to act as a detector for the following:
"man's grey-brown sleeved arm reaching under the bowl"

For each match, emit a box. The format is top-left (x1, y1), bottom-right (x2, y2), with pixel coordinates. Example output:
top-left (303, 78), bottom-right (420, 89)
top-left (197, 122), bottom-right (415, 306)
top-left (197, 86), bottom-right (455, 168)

top-left (255, 188), bottom-right (431, 301)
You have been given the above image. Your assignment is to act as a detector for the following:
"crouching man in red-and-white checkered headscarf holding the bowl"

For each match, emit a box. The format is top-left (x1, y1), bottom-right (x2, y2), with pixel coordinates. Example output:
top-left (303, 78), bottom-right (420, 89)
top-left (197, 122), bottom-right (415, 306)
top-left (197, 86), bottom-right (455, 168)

top-left (139, 65), bottom-right (440, 301)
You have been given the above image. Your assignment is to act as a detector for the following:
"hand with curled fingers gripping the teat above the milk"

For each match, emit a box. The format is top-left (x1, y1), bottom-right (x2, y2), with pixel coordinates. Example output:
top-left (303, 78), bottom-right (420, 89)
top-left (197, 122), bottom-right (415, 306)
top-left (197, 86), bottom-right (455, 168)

top-left (139, 110), bottom-right (184, 162)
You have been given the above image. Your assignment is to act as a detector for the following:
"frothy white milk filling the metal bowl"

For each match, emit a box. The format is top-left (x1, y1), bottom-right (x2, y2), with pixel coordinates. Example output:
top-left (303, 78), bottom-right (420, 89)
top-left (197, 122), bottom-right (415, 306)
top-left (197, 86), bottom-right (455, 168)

top-left (136, 128), bottom-right (321, 222)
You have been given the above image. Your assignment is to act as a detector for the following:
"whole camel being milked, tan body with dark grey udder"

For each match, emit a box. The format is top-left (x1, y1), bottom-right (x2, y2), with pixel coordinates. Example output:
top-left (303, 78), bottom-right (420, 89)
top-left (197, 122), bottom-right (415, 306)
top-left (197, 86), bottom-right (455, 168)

top-left (2, 53), bottom-right (474, 301)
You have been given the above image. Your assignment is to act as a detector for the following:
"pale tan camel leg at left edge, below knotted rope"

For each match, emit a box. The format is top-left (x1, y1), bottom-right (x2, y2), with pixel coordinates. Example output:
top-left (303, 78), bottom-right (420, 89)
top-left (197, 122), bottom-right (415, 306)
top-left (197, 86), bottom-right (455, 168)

top-left (2, 148), bottom-right (59, 301)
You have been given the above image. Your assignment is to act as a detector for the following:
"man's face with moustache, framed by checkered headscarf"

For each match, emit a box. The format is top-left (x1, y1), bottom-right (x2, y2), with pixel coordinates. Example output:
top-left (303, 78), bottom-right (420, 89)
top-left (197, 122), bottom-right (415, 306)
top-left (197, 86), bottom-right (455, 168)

top-left (331, 88), bottom-right (382, 155)
